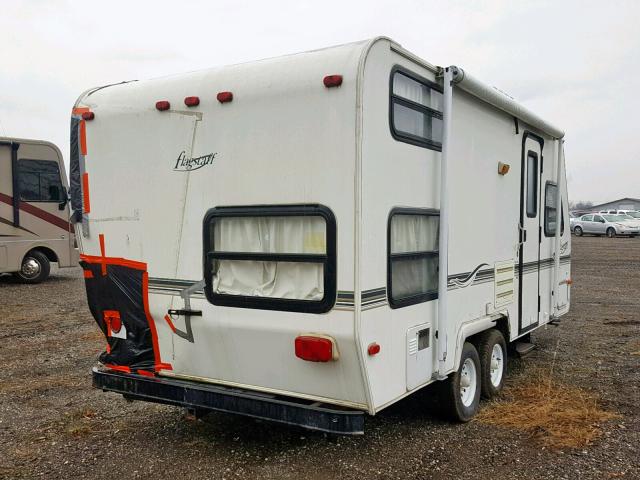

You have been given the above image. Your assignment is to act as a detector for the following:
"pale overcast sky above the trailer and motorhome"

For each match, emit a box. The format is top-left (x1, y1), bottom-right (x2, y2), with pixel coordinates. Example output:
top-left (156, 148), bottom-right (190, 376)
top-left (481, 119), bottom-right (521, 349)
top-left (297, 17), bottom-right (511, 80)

top-left (0, 0), bottom-right (640, 202)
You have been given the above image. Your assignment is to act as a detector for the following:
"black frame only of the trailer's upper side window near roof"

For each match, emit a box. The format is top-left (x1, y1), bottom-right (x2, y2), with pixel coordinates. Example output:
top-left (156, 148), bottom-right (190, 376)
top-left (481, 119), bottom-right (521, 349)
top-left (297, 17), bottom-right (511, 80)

top-left (389, 65), bottom-right (444, 152)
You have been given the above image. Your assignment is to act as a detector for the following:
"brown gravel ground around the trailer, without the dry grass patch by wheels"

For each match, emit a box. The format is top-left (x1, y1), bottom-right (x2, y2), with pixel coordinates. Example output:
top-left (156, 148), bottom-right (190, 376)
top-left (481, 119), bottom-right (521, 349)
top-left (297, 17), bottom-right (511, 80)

top-left (0, 237), bottom-right (640, 480)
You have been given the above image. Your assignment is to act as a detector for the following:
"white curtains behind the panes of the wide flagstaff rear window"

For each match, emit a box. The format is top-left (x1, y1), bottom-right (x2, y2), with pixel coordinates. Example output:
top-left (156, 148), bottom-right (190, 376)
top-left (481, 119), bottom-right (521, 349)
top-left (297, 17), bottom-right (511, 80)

top-left (212, 216), bottom-right (326, 300)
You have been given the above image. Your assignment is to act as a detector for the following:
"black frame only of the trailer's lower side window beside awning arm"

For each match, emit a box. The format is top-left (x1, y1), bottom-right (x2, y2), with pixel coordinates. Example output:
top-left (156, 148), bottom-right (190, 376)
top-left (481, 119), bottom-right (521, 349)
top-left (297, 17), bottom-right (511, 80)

top-left (387, 207), bottom-right (440, 309)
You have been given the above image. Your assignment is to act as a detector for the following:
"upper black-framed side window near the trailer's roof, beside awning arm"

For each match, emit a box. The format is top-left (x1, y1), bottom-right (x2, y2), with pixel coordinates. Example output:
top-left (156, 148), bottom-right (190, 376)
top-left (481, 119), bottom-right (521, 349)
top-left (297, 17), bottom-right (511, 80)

top-left (389, 67), bottom-right (443, 151)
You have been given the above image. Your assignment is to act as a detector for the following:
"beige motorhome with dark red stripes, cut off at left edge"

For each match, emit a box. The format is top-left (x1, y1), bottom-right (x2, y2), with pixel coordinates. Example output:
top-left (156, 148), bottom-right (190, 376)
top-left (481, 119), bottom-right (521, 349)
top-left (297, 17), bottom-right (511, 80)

top-left (0, 137), bottom-right (78, 283)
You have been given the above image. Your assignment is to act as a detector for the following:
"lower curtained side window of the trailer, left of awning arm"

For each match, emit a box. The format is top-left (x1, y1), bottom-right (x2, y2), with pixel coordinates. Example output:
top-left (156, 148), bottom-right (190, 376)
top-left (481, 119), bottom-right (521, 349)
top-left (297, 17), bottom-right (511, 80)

top-left (387, 209), bottom-right (440, 308)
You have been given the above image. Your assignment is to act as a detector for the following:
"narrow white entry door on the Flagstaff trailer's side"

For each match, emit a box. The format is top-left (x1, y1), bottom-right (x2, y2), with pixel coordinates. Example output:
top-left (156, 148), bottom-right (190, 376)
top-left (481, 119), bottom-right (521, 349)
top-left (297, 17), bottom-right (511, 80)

top-left (518, 134), bottom-right (542, 333)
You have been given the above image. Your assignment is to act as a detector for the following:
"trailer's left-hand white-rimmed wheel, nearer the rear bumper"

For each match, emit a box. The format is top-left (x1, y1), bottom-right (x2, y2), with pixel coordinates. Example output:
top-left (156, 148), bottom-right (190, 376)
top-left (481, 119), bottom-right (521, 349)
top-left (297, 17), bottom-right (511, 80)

top-left (440, 342), bottom-right (481, 422)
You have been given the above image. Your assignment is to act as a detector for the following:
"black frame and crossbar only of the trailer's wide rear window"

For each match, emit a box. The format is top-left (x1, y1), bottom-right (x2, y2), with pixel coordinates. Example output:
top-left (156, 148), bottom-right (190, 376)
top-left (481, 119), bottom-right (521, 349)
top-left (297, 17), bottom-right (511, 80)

top-left (202, 204), bottom-right (337, 313)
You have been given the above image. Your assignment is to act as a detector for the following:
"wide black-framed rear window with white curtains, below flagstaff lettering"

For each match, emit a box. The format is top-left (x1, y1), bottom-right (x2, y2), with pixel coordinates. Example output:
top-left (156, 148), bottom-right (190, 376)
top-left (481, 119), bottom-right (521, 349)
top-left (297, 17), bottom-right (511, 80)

top-left (204, 205), bottom-right (336, 313)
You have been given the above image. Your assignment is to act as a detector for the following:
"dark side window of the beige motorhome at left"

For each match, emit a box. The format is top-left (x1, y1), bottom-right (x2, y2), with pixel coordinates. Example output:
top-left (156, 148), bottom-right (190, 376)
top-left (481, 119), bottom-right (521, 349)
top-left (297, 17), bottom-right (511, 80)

top-left (18, 159), bottom-right (63, 202)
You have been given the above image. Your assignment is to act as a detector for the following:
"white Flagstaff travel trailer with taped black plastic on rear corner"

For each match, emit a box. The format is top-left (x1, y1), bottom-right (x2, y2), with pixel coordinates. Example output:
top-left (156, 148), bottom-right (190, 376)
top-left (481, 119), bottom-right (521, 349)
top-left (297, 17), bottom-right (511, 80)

top-left (71, 38), bottom-right (571, 433)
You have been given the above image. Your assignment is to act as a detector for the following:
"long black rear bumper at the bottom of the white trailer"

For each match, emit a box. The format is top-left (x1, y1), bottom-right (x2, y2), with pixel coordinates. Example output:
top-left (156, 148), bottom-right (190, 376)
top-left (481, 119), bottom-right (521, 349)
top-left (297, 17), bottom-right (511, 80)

top-left (93, 367), bottom-right (364, 435)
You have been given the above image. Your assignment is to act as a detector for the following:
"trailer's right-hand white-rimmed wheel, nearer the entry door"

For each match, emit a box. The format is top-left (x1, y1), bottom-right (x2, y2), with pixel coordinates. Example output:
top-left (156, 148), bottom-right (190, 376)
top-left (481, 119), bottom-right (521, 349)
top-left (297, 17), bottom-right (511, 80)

top-left (476, 328), bottom-right (507, 398)
